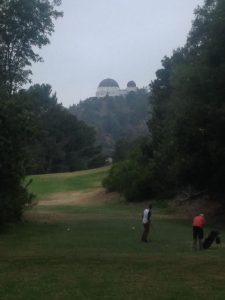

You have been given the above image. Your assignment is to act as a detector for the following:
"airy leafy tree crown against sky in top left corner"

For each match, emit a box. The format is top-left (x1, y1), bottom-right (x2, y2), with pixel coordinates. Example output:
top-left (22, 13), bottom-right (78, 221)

top-left (0, 0), bottom-right (62, 95)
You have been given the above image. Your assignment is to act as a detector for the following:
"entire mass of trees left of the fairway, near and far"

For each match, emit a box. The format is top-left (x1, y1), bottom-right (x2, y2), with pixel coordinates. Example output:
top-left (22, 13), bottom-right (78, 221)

top-left (0, 0), bottom-right (103, 224)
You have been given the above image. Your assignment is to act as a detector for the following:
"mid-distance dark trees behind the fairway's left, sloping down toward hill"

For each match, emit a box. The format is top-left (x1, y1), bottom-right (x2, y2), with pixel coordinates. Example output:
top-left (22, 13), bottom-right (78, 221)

top-left (18, 85), bottom-right (104, 174)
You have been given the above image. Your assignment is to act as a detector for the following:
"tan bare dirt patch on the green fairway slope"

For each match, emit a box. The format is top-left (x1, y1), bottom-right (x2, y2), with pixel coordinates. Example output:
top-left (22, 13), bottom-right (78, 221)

top-left (38, 188), bottom-right (118, 206)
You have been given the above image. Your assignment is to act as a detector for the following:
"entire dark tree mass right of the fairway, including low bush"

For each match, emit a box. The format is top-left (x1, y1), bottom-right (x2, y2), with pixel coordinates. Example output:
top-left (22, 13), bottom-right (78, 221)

top-left (104, 0), bottom-right (225, 201)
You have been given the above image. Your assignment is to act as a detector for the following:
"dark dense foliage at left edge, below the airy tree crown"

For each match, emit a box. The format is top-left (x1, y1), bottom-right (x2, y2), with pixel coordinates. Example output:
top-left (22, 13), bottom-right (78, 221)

top-left (0, 98), bottom-right (32, 224)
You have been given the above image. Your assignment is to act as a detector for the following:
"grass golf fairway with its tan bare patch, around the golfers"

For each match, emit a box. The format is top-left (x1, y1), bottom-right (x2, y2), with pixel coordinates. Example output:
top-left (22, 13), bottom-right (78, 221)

top-left (0, 169), bottom-right (225, 300)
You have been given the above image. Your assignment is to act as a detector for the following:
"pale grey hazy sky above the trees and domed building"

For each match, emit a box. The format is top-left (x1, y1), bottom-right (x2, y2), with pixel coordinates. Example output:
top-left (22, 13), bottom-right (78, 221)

top-left (29, 0), bottom-right (203, 107)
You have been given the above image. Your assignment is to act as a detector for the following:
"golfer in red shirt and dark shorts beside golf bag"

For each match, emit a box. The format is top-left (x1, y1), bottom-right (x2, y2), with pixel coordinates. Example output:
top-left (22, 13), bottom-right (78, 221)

top-left (192, 214), bottom-right (206, 250)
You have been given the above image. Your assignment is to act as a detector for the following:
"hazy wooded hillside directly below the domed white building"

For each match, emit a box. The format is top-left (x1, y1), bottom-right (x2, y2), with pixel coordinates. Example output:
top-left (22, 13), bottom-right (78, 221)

top-left (69, 89), bottom-right (149, 155)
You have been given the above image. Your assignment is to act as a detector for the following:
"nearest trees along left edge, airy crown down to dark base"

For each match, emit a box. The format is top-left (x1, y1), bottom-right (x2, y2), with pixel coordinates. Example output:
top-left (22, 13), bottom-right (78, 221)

top-left (0, 0), bottom-right (62, 223)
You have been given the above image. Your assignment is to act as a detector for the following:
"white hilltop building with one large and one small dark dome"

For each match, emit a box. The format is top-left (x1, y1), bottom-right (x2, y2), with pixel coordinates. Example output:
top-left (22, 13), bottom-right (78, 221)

top-left (96, 78), bottom-right (137, 98)
